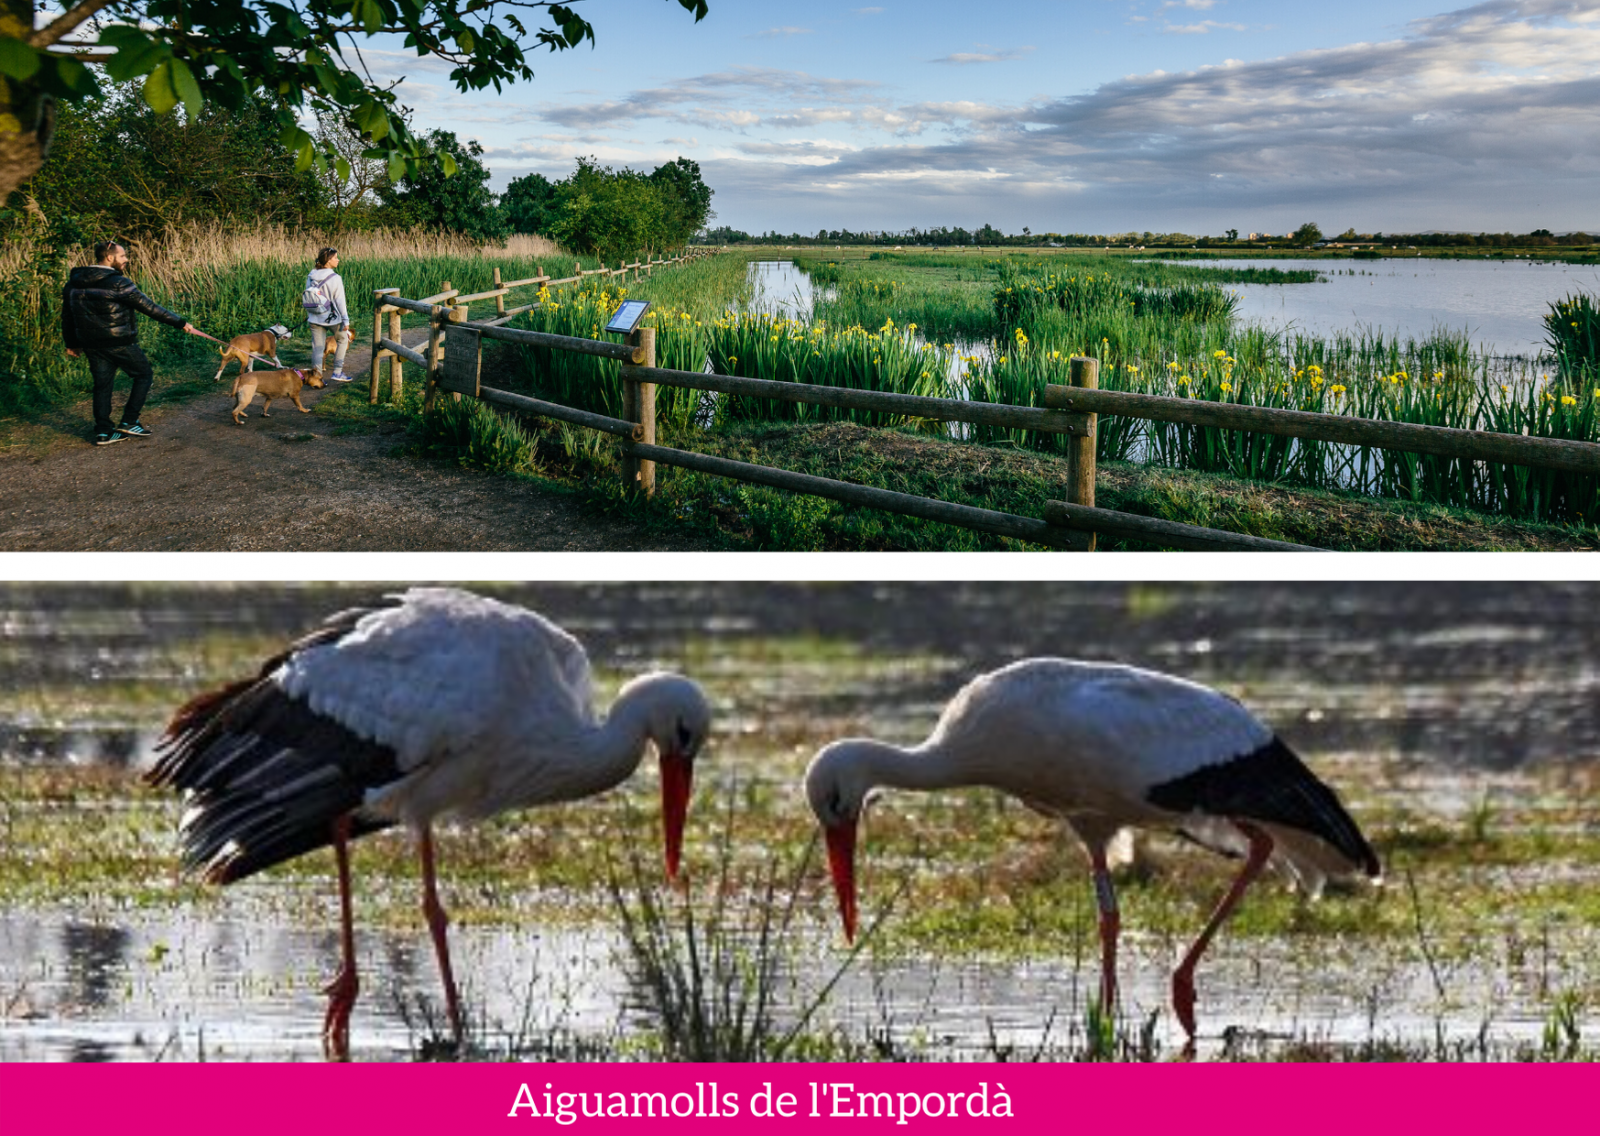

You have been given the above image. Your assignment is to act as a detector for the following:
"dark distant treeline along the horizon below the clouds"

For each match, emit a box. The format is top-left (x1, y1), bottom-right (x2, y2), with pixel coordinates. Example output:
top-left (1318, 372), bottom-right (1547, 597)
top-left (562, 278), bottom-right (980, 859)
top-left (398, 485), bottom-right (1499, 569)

top-left (702, 222), bottom-right (1600, 248)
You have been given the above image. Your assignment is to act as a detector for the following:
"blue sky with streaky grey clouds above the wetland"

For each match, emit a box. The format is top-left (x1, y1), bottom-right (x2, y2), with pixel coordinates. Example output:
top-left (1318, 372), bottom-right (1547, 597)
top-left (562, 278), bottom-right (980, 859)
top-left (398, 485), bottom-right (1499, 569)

top-left (366, 0), bottom-right (1600, 235)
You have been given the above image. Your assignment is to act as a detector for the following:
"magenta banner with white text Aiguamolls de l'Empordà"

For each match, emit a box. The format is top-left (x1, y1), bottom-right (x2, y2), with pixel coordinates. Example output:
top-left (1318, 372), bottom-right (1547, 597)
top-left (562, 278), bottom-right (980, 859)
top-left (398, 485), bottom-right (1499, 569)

top-left (0, 1064), bottom-right (1600, 1136)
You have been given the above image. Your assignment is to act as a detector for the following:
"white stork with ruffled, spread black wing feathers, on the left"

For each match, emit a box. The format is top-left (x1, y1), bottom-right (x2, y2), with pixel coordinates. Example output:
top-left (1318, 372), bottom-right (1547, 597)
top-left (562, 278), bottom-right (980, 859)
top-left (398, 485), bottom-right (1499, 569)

top-left (146, 587), bottom-right (710, 1058)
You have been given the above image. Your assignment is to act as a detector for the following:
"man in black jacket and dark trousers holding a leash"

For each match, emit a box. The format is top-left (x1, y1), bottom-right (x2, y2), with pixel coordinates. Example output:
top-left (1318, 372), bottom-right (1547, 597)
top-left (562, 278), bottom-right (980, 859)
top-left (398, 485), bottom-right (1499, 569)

top-left (61, 240), bottom-right (200, 446)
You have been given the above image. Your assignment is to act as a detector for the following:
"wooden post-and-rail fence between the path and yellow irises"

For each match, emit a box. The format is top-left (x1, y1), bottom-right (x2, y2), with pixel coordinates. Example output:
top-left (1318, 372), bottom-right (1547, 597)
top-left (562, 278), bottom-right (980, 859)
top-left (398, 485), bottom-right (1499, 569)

top-left (371, 264), bottom-right (1600, 552)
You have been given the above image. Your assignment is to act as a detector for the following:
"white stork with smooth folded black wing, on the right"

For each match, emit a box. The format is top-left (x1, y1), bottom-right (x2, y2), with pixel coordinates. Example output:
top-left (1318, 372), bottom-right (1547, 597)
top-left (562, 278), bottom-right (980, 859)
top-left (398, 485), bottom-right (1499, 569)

top-left (805, 659), bottom-right (1381, 1037)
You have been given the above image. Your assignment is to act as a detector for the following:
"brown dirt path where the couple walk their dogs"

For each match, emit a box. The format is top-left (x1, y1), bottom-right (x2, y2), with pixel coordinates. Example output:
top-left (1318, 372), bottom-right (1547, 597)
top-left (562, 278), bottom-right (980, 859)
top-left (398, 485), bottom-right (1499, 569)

top-left (0, 330), bottom-right (707, 552)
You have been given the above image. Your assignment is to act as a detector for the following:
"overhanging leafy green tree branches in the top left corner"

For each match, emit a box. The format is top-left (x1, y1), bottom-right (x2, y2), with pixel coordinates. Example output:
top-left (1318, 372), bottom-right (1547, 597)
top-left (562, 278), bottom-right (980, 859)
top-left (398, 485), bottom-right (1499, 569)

top-left (0, 0), bottom-right (707, 198)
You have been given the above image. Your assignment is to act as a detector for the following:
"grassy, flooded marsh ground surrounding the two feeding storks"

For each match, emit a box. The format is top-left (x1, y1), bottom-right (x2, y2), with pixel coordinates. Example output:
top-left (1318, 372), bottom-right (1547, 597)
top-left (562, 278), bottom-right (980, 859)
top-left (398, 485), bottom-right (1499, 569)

top-left (0, 582), bottom-right (1600, 1061)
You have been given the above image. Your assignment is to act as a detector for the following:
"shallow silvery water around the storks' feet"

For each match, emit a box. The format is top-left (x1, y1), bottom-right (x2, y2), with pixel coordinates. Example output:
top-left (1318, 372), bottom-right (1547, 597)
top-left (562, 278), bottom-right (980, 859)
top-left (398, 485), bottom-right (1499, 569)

top-left (0, 885), bottom-right (1600, 1061)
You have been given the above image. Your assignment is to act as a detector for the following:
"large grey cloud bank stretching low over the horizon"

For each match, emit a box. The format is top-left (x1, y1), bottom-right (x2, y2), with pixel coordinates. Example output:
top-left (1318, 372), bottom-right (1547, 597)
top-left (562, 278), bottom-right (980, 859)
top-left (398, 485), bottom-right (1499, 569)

top-left (480, 0), bottom-right (1600, 232)
